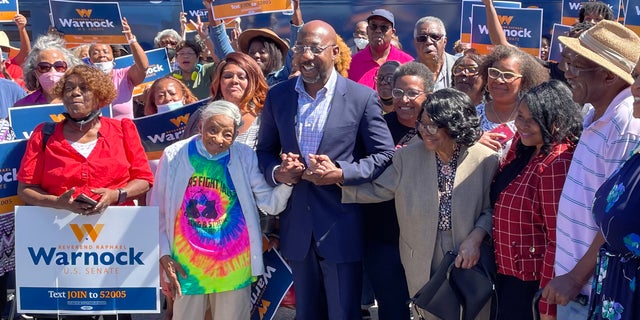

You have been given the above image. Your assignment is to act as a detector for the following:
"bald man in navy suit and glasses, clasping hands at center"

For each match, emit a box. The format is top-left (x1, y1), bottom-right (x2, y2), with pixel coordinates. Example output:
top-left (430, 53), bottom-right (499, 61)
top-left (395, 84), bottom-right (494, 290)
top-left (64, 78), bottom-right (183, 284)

top-left (257, 20), bottom-right (393, 320)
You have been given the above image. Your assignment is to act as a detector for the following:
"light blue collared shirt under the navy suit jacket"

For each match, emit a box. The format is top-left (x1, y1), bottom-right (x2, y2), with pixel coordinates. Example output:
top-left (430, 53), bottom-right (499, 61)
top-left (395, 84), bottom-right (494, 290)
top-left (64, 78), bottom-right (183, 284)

top-left (295, 69), bottom-right (338, 163)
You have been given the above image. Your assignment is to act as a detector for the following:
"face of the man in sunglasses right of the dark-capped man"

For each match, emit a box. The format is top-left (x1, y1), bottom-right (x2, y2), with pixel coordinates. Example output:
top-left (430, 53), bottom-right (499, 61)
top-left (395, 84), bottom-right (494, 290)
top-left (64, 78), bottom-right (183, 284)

top-left (413, 22), bottom-right (447, 72)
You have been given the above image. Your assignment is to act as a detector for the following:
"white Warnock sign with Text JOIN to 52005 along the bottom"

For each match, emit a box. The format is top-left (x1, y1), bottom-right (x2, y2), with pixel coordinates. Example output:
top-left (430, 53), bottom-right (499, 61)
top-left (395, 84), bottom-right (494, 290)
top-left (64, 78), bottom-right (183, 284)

top-left (15, 206), bottom-right (160, 314)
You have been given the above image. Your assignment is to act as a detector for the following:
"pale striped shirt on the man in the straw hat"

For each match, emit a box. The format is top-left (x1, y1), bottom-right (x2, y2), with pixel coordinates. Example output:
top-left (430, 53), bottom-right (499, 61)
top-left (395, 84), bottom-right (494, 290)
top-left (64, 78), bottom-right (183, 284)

top-left (555, 88), bottom-right (640, 295)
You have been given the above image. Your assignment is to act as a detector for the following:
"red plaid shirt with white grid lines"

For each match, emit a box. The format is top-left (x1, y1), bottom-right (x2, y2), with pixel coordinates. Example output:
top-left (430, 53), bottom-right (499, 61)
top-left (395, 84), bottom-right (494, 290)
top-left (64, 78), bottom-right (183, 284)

top-left (493, 144), bottom-right (575, 315)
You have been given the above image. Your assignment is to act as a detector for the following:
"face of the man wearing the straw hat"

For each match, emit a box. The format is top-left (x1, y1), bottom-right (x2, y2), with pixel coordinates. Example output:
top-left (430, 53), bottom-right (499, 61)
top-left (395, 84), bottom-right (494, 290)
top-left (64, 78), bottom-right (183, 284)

top-left (560, 47), bottom-right (606, 104)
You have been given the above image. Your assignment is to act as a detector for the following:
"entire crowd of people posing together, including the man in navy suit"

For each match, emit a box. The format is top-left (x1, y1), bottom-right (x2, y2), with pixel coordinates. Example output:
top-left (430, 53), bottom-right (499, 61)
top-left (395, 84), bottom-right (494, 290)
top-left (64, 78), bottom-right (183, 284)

top-left (0, 0), bottom-right (640, 320)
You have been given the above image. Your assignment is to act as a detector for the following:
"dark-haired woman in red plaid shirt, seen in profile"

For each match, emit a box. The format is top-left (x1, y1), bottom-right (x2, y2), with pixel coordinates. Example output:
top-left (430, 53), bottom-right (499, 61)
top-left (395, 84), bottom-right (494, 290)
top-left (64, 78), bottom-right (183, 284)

top-left (491, 80), bottom-right (582, 319)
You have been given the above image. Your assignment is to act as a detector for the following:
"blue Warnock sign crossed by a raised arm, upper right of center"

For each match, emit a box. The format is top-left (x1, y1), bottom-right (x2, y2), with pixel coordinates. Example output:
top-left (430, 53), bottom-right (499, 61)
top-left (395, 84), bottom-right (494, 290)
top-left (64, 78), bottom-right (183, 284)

top-left (471, 5), bottom-right (542, 57)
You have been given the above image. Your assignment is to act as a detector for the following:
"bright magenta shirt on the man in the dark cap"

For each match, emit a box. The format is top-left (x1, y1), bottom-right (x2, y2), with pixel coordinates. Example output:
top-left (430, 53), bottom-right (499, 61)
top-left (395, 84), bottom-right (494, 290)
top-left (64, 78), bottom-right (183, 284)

top-left (349, 45), bottom-right (414, 89)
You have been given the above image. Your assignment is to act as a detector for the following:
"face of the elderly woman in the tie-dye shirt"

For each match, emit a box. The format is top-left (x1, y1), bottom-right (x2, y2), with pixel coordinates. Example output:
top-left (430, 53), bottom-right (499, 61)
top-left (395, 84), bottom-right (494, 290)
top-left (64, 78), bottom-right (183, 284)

top-left (201, 114), bottom-right (235, 155)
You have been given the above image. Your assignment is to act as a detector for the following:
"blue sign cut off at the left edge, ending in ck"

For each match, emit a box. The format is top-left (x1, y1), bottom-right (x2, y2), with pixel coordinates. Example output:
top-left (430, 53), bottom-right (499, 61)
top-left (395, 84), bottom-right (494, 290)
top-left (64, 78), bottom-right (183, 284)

top-left (0, 140), bottom-right (27, 217)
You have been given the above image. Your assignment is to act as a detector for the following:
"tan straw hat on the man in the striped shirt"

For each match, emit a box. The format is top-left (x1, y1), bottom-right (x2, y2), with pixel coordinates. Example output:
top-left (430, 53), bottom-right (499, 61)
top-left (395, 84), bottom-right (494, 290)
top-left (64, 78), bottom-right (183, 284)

top-left (558, 20), bottom-right (640, 84)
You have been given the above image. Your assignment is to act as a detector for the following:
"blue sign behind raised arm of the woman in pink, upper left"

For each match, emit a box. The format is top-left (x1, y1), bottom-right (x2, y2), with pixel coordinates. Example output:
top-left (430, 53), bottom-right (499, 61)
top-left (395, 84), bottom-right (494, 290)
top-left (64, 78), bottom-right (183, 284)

top-left (115, 48), bottom-right (171, 96)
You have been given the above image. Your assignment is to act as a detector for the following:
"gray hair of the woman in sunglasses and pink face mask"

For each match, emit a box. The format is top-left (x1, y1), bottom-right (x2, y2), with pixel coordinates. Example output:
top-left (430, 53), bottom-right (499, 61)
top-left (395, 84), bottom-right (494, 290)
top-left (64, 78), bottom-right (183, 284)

top-left (22, 33), bottom-right (84, 90)
